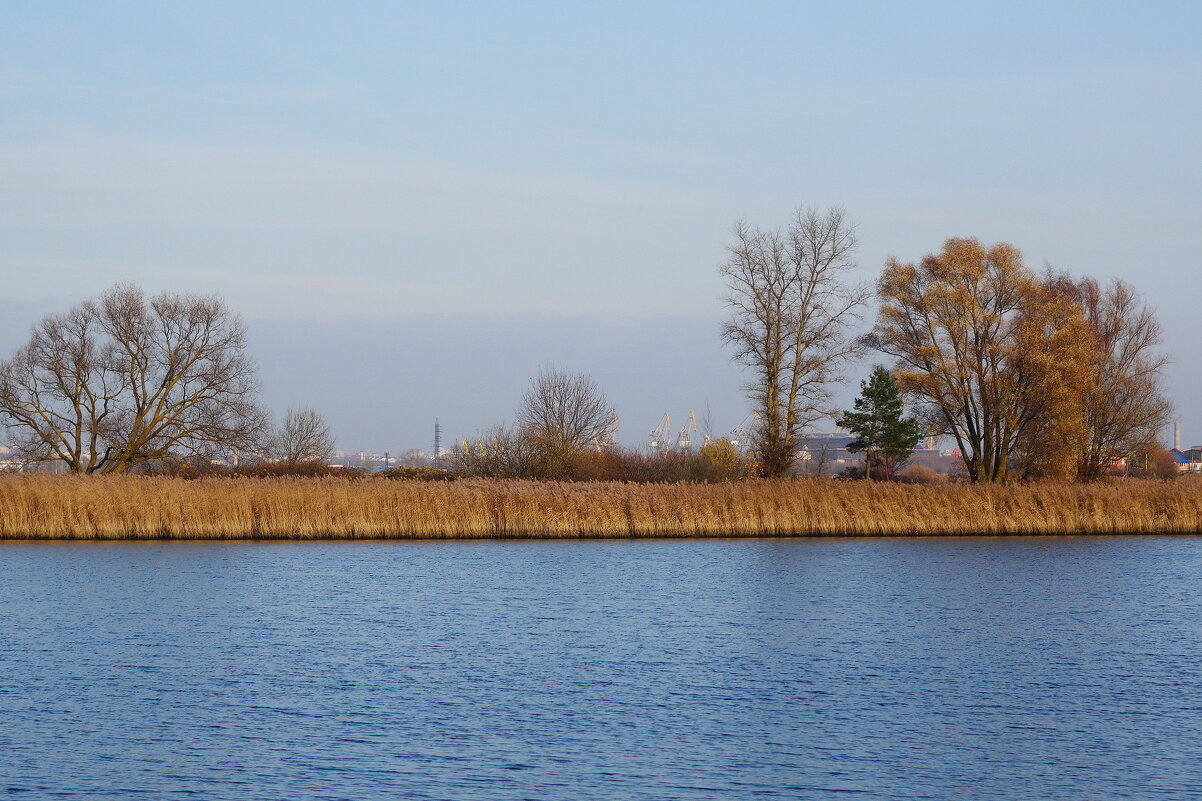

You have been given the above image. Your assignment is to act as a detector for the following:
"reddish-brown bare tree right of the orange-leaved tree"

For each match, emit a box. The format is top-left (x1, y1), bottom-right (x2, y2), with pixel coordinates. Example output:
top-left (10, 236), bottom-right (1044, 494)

top-left (1046, 273), bottom-right (1173, 481)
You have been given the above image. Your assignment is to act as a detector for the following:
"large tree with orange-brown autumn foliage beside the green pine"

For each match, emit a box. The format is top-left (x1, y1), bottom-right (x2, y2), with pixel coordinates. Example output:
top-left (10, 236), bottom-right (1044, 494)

top-left (867, 238), bottom-right (1094, 482)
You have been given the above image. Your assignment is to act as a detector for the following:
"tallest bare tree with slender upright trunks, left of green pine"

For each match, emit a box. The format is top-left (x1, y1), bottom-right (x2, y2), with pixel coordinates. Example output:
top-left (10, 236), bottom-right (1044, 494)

top-left (720, 208), bottom-right (870, 476)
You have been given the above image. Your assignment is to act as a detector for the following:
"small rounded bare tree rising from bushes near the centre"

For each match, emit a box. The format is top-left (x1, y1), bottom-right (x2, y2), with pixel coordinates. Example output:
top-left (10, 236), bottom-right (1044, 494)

top-left (517, 367), bottom-right (618, 451)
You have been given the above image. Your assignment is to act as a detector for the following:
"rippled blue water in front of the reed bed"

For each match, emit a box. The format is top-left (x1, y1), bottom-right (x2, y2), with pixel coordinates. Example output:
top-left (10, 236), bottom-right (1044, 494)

top-left (0, 538), bottom-right (1202, 801)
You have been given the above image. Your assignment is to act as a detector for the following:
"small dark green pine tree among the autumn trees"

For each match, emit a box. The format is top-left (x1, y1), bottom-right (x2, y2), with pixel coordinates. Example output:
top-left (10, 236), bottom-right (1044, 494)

top-left (837, 367), bottom-right (922, 479)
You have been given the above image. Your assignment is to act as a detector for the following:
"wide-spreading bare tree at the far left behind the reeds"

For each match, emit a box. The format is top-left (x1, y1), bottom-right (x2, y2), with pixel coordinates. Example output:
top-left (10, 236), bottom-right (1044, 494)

top-left (0, 284), bottom-right (267, 473)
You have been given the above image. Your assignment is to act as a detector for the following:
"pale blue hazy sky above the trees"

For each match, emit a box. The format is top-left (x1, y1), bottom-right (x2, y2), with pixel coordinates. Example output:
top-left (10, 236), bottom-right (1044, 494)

top-left (0, 0), bottom-right (1202, 451)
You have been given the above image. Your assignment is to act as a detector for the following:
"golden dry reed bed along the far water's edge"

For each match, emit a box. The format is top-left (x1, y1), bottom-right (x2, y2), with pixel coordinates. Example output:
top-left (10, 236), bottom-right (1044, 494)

top-left (0, 475), bottom-right (1202, 539)
